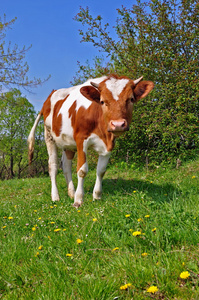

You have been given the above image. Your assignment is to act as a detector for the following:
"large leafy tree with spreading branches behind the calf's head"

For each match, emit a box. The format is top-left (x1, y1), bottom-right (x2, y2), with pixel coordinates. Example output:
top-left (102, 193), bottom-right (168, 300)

top-left (75, 0), bottom-right (199, 164)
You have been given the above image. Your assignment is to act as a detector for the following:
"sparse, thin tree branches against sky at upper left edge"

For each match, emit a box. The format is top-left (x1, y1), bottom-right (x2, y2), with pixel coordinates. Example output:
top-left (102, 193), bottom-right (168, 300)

top-left (0, 15), bottom-right (49, 91)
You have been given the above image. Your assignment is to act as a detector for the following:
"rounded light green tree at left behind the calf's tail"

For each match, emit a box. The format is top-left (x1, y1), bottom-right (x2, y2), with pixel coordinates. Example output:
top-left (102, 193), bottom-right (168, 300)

top-left (0, 89), bottom-right (46, 179)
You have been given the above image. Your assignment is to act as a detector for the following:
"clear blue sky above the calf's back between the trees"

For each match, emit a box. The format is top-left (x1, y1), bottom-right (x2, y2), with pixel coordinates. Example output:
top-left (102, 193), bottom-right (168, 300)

top-left (0, 0), bottom-right (136, 111)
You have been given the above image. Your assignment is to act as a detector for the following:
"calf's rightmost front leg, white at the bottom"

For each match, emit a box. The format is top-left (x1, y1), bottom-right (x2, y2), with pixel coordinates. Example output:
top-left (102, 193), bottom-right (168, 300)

top-left (93, 154), bottom-right (110, 200)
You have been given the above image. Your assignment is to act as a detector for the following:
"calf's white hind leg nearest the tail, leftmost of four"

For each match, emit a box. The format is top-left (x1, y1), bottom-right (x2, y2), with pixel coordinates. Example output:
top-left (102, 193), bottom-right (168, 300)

top-left (45, 127), bottom-right (59, 201)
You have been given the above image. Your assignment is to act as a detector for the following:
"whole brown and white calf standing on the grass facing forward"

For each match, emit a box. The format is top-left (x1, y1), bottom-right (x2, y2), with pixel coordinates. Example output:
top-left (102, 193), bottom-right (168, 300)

top-left (28, 75), bottom-right (154, 207)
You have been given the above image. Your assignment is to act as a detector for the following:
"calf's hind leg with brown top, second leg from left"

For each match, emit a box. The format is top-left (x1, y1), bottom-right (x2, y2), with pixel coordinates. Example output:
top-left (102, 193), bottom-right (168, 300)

top-left (62, 150), bottom-right (75, 198)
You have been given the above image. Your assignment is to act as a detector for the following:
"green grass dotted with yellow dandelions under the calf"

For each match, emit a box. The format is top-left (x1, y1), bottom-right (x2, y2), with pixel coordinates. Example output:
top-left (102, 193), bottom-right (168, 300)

top-left (0, 161), bottom-right (199, 300)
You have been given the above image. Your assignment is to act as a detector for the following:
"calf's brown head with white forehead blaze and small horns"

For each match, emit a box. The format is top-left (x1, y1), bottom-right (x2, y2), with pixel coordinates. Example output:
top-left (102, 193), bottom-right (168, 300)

top-left (80, 75), bottom-right (154, 136)
